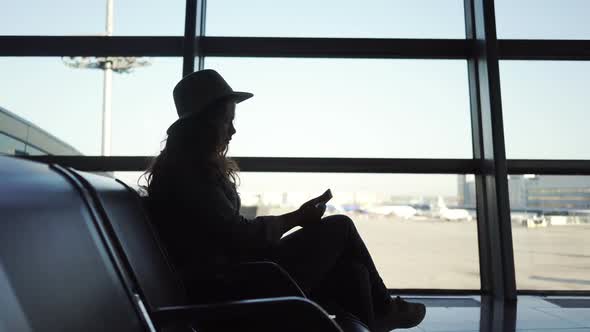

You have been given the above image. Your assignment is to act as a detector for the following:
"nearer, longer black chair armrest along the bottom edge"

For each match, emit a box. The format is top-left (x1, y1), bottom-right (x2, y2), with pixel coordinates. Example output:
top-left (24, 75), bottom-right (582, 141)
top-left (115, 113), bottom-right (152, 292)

top-left (152, 297), bottom-right (342, 332)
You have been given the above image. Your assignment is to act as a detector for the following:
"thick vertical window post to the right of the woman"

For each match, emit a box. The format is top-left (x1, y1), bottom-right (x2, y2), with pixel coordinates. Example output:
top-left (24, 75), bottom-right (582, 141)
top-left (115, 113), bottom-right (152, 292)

top-left (465, 0), bottom-right (516, 301)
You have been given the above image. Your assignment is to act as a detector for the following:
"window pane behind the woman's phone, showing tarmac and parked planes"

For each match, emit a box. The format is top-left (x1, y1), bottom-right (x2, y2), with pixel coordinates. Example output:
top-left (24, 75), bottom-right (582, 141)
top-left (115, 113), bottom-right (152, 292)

top-left (120, 172), bottom-right (480, 289)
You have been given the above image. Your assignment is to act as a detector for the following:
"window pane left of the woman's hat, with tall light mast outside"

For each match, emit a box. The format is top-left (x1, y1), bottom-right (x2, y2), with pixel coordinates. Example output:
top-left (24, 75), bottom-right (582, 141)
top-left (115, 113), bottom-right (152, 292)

top-left (0, 58), bottom-right (182, 155)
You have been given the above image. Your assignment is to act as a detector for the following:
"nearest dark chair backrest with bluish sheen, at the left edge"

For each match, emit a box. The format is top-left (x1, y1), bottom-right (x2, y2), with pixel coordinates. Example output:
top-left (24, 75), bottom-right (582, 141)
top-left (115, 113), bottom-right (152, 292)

top-left (0, 156), bottom-right (146, 332)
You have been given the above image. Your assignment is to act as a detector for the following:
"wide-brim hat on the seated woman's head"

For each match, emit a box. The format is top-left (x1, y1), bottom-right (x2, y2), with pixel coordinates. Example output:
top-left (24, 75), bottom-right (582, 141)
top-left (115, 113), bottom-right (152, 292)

top-left (166, 69), bottom-right (254, 134)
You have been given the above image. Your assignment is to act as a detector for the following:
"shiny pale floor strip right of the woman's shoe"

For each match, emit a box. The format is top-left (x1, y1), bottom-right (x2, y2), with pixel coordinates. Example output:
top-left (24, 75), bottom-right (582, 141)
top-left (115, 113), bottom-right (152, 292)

top-left (396, 296), bottom-right (590, 332)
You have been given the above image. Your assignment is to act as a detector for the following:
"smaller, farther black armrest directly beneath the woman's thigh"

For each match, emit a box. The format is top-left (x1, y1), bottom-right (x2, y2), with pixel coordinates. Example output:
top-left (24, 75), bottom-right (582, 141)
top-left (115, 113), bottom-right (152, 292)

top-left (224, 261), bottom-right (306, 298)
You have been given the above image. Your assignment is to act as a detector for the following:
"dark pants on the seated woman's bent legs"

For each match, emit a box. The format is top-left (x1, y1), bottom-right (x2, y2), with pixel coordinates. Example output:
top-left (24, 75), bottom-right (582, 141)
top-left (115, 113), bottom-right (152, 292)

top-left (272, 215), bottom-right (389, 327)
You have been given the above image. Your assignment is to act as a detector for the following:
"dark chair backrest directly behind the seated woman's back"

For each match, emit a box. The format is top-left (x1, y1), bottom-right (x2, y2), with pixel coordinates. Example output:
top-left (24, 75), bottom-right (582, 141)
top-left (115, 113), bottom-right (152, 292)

top-left (70, 172), bottom-right (187, 309)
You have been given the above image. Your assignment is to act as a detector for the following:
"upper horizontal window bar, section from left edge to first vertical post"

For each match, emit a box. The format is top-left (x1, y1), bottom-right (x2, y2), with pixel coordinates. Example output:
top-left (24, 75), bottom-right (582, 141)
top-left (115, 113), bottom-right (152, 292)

top-left (0, 36), bottom-right (183, 57)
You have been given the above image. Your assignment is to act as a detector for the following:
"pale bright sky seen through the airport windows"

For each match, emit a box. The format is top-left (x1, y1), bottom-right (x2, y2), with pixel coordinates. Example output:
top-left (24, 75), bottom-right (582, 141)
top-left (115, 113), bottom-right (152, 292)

top-left (0, 0), bottom-right (590, 195)
